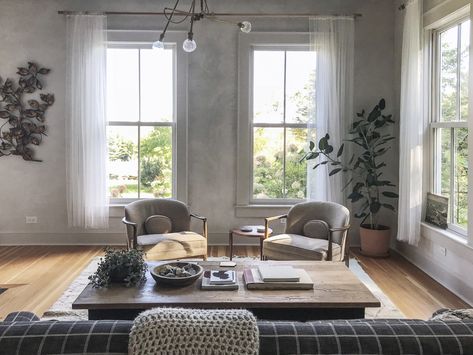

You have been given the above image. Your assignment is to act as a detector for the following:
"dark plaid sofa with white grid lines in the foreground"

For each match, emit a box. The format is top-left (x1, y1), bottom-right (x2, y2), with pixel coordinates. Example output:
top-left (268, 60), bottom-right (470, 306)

top-left (0, 312), bottom-right (473, 355)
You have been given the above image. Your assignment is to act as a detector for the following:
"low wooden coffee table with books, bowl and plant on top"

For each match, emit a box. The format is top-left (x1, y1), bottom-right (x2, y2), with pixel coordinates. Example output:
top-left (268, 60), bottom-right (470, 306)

top-left (72, 261), bottom-right (380, 321)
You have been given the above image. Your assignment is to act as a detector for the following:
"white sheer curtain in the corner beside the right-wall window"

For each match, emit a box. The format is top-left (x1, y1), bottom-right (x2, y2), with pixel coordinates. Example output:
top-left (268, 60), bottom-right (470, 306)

top-left (397, 0), bottom-right (425, 245)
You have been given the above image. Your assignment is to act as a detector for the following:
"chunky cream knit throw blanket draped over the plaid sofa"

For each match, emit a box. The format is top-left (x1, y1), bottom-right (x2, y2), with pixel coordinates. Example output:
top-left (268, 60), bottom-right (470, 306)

top-left (128, 308), bottom-right (259, 355)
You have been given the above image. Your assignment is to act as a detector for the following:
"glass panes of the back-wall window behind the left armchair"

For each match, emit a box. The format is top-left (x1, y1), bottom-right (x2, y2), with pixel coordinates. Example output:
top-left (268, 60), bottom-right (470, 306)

top-left (107, 45), bottom-right (176, 201)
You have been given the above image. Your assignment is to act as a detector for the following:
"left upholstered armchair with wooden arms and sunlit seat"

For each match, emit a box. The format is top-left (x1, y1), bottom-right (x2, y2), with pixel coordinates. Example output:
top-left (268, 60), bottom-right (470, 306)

top-left (122, 199), bottom-right (207, 260)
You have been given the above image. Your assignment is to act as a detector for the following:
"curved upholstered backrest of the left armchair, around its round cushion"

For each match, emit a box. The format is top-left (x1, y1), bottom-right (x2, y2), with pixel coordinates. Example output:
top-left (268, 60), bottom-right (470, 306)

top-left (125, 198), bottom-right (190, 235)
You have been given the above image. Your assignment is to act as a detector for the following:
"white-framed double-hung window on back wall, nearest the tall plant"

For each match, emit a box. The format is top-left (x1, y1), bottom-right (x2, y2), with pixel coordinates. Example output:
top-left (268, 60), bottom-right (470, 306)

top-left (237, 33), bottom-right (316, 210)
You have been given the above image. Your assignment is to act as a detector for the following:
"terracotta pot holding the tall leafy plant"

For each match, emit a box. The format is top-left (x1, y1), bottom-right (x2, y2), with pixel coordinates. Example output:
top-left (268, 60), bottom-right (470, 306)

top-left (360, 224), bottom-right (391, 258)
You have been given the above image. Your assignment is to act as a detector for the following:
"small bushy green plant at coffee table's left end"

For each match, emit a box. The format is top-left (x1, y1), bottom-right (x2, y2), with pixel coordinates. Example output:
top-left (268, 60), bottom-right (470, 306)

top-left (89, 248), bottom-right (148, 288)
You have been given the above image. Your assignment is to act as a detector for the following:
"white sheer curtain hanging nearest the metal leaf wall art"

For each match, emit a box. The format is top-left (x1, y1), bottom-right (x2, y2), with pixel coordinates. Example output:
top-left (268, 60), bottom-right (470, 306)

top-left (66, 15), bottom-right (108, 228)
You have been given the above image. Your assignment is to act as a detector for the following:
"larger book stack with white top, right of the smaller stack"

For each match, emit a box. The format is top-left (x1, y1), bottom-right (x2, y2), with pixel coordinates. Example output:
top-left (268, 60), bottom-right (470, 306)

top-left (243, 265), bottom-right (314, 290)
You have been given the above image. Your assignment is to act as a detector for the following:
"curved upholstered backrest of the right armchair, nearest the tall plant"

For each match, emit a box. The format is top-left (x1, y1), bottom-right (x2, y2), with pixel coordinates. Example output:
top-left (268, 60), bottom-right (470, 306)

top-left (286, 201), bottom-right (350, 244)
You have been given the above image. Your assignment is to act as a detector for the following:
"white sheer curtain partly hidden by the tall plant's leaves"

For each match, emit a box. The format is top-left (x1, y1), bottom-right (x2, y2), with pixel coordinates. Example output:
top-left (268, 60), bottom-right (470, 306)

top-left (307, 16), bottom-right (355, 204)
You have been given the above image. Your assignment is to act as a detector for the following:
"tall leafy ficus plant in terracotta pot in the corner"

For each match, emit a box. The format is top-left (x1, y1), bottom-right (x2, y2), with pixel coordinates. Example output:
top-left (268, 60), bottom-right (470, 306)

top-left (303, 99), bottom-right (398, 257)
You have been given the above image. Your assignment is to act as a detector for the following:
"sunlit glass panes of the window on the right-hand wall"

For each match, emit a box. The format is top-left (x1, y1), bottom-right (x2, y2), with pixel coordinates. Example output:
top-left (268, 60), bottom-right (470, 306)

top-left (436, 22), bottom-right (469, 228)
